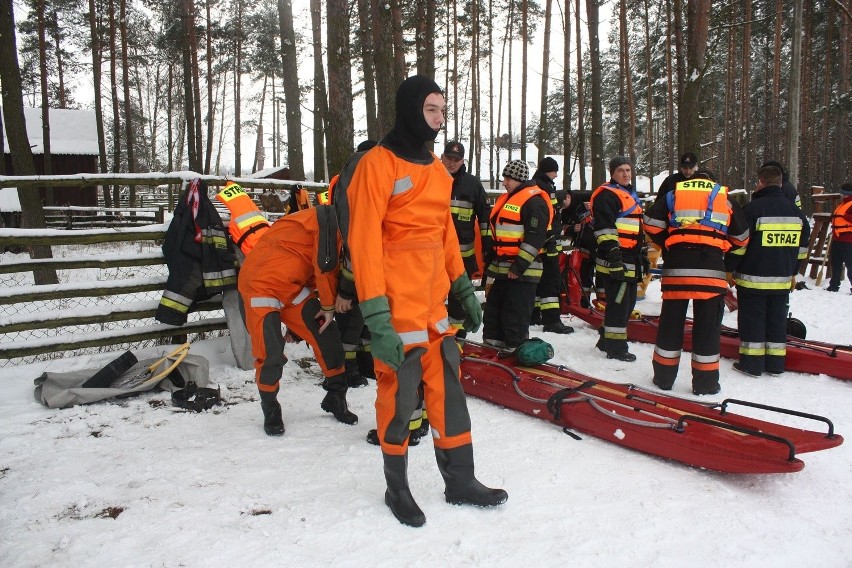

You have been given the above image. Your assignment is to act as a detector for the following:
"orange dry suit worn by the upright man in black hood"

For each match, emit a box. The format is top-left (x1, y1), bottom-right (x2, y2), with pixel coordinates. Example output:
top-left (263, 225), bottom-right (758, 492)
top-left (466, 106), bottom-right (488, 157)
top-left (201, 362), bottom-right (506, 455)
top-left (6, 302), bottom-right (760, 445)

top-left (346, 144), bottom-right (471, 455)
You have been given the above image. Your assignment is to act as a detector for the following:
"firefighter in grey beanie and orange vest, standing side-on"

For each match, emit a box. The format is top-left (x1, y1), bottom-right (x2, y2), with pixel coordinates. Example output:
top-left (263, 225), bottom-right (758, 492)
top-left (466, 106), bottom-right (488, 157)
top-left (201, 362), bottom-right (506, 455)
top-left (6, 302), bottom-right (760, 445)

top-left (591, 156), bottom-right (647, 362)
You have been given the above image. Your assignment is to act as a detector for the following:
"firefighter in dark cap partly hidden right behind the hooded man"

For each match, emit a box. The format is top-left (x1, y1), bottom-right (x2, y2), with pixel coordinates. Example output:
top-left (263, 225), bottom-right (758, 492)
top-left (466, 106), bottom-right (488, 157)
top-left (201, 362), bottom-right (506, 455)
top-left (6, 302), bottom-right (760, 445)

top-left (441, 141), bottom-right (491, 338)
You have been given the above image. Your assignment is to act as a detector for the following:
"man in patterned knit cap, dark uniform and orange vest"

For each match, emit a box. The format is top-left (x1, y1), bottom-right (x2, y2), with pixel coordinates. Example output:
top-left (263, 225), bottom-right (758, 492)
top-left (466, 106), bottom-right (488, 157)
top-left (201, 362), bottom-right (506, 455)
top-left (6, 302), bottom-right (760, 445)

top-left (482, 160), bottom-right (553, 351)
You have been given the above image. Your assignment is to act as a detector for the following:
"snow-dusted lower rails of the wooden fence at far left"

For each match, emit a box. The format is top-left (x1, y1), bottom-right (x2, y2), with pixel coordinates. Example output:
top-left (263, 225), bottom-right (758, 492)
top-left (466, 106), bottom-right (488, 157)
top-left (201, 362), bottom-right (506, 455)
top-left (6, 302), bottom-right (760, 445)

top-left (0, 224), bottom-right (227, 365)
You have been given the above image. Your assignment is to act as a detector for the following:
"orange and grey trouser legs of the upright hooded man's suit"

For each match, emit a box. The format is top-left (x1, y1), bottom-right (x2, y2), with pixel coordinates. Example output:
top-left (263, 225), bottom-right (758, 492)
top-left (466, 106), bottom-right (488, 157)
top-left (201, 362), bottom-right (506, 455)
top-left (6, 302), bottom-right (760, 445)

top-left (375, 335), bottom-right (471, 455)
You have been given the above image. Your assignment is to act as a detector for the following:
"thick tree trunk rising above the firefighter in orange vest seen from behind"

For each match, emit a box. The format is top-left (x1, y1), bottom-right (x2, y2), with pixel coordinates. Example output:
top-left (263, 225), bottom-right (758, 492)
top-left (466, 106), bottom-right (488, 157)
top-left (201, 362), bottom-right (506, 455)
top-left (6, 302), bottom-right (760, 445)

top-left (677, 0), bottom-right (712, 157)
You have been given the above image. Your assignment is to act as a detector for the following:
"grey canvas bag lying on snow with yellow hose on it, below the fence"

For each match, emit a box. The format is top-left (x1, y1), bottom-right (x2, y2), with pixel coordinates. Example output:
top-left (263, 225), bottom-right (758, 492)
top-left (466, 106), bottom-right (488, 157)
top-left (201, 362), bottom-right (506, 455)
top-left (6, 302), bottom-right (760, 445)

top-left (33, 345), bottom-right (210, 408)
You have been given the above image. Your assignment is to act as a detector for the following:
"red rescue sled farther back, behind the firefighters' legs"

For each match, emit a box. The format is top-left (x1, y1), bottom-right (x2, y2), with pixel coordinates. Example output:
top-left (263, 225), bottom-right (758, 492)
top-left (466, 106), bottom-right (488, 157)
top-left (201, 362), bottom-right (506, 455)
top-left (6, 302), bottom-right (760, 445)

top-left (562, 250), bottom-right (852, 381)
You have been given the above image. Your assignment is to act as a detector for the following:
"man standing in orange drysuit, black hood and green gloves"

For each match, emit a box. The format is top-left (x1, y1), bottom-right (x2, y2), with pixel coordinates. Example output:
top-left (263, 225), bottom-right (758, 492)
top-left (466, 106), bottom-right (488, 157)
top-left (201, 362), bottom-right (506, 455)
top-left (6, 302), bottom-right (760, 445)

top-left (347, 75), bottom-right (508, 526)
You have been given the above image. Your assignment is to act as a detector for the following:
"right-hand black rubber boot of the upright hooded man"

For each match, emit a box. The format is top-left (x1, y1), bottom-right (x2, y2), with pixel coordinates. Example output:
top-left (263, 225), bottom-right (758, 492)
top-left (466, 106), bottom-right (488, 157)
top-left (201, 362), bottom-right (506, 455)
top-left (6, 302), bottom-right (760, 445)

top-left (435, 444), bottom-right (509, 507)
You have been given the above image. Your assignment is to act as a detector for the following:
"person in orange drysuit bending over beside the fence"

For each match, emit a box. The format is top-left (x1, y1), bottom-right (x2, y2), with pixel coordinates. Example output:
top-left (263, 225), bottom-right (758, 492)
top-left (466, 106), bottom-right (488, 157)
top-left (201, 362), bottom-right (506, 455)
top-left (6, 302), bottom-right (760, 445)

top-left (237, 206), bottom-right (358, 436)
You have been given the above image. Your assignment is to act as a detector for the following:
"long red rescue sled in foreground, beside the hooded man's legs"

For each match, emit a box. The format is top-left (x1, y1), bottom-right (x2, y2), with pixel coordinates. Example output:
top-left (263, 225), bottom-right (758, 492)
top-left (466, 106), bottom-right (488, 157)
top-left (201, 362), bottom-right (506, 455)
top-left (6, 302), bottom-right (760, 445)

top-left (461, 341), bottom-right (843, 473)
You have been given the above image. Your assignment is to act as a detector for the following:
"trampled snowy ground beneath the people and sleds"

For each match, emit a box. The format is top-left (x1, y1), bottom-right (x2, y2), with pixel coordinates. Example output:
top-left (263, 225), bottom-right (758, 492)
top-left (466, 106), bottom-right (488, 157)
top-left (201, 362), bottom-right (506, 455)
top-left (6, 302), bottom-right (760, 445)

top-left (0, 274), bottom-right (852, 568)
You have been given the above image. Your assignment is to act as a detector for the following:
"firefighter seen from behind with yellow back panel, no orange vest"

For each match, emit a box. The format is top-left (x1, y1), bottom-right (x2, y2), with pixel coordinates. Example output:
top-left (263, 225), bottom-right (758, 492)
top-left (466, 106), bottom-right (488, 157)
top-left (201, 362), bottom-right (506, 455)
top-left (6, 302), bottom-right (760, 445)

top-left (731, 166), bottom-right (811, 377)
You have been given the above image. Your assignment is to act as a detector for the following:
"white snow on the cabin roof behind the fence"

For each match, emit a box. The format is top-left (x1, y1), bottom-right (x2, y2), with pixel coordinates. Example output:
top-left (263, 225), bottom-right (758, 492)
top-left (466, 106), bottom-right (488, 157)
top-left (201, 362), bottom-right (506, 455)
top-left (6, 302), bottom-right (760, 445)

top-left (3, 107), bottom-right (98, 156)
